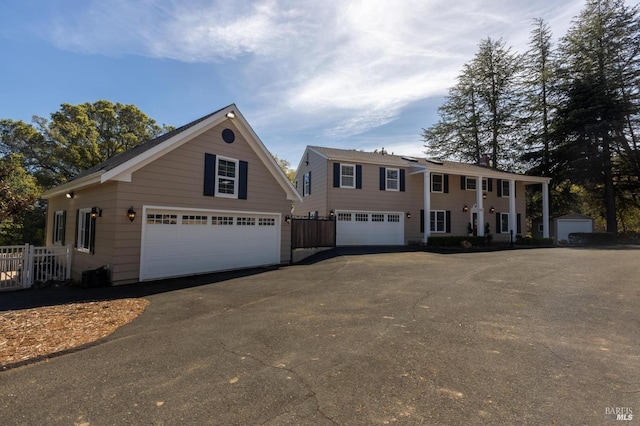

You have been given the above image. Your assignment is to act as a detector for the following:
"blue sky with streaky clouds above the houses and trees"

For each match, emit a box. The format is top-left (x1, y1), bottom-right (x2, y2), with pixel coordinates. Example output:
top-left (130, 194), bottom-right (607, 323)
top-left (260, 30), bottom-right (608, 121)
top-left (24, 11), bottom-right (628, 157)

top-left (0, 0), bottom-right (630, 168)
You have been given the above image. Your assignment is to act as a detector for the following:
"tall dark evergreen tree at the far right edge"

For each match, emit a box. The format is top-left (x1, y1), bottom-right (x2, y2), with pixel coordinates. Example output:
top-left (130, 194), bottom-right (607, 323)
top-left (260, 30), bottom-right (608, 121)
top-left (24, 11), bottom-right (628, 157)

top-left (554, 0), bottom-right (640, 233)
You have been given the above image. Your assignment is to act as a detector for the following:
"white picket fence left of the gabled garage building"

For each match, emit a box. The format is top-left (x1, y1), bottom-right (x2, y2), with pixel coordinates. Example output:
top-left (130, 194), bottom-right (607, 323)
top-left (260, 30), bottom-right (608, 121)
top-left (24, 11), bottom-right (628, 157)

top-left (0, 244), bottom-right (71, 290)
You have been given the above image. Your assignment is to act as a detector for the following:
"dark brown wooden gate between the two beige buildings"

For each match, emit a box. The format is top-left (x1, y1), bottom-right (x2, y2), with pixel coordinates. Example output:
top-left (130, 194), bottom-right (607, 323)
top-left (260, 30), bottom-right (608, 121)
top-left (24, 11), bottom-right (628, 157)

top-left (291, 217), bottom-right (336, 250)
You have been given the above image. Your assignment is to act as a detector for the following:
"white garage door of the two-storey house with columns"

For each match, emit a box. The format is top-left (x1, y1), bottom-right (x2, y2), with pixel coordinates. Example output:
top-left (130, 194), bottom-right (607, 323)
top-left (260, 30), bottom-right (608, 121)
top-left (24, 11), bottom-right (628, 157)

top-left (336, 211), bottom-right (404, 246)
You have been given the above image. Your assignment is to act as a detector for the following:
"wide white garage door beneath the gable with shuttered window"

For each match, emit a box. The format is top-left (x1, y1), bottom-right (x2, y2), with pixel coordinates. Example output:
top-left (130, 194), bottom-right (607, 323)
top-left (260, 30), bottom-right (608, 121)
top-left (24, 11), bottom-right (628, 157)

top-left (140, 209), bottom-right (280, 281)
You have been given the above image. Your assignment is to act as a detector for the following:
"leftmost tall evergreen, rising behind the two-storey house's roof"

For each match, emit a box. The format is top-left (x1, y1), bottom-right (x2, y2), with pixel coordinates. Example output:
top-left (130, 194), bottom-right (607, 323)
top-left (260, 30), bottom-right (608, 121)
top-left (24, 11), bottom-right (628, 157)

top-left (422, 38), bottom-right (521, 169)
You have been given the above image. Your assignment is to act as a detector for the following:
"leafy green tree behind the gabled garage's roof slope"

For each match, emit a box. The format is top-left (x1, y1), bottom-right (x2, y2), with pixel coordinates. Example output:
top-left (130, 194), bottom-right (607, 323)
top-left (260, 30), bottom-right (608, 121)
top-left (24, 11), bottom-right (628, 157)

top-left (0, 100), bottom-right (171, 188)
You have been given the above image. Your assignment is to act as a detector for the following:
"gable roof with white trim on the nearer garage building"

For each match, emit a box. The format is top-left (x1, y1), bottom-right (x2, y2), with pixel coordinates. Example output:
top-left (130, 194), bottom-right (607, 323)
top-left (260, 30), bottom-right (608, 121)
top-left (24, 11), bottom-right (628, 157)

top-left (42, 104), bottom-right (302, 201)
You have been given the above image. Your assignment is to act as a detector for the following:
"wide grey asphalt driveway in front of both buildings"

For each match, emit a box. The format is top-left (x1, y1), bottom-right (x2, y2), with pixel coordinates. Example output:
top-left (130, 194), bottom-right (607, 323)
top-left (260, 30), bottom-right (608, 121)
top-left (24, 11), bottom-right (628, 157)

top-left (0, 248), bottom-right (640, 426)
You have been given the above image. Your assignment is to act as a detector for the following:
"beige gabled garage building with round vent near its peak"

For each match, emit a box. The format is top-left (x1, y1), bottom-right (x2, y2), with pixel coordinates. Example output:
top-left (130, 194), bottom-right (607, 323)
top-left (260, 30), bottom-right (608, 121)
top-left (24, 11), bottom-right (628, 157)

top-left (43, 105), bottom-right (300, 284)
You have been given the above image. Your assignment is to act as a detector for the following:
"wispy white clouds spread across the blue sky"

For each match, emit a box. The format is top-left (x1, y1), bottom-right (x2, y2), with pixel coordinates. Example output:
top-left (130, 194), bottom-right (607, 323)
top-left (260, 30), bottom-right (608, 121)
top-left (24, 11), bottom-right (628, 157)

top-left (45, 0), bottom-right (583, 143)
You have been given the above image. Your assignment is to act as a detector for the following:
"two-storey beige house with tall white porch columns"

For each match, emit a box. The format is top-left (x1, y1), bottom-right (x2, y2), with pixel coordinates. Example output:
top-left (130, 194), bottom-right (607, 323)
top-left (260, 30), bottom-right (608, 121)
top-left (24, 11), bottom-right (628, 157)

top-left (295, 146), bottom-right (549, 246)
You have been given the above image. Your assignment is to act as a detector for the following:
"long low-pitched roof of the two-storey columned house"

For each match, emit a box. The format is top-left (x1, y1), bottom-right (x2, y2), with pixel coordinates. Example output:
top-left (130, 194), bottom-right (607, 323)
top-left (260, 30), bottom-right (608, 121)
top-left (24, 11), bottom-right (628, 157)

top-left (307, 146), bottom-right (550, 183)
